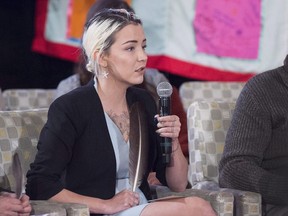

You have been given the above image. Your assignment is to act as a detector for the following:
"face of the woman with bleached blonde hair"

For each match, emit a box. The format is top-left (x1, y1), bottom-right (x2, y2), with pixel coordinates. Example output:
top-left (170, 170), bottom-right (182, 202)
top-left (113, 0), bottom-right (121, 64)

top-left (104, 24), bottom-right (147, 86)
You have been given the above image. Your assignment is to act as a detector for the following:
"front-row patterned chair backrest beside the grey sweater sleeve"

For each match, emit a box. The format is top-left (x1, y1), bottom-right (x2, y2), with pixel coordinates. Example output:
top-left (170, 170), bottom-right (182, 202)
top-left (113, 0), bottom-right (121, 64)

top-left (187, 101), bottom-right (236, 186)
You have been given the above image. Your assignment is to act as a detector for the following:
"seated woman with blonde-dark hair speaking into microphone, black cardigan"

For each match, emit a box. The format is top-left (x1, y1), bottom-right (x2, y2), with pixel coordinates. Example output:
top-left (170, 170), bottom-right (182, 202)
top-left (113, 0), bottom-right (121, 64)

top-left (26, 9), bottom-right (214, 216)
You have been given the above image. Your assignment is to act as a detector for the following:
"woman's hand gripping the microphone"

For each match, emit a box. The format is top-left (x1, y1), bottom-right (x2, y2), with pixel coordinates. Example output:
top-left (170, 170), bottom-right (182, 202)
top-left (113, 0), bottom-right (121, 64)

top-left (155, 115), bottom-right (181, 141)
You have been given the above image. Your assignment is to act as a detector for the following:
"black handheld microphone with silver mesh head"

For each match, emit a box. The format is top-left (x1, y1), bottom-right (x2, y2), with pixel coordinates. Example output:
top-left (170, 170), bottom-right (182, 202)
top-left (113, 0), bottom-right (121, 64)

top-left (157, 82), bottom-right (173, 164)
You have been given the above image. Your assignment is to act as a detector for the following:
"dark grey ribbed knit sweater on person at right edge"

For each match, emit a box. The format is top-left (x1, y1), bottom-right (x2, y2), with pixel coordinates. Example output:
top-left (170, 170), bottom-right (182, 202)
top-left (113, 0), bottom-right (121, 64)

top-left (219, 56), bottom-right (288, 206)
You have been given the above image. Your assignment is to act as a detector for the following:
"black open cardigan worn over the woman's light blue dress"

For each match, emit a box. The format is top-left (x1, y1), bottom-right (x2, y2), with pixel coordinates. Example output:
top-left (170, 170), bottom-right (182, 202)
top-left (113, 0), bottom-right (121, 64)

top-left (26, 83), bottom-right (166, 206)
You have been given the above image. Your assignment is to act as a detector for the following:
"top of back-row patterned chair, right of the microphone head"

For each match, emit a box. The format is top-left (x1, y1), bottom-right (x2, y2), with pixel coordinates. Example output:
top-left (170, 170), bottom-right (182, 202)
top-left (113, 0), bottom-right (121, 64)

top-left (179, 81), bottom-right (246, 111)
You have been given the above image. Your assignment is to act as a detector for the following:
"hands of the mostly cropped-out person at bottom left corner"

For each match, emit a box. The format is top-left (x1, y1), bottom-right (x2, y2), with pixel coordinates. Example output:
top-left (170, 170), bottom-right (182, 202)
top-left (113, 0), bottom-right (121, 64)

top-left (0, 192), bottom-right (31, 216)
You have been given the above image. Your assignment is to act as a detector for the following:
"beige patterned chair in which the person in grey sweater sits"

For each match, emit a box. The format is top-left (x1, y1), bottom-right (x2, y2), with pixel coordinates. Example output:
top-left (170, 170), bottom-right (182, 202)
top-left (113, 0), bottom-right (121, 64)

top-left (187, 101), bottom-right (261, 216)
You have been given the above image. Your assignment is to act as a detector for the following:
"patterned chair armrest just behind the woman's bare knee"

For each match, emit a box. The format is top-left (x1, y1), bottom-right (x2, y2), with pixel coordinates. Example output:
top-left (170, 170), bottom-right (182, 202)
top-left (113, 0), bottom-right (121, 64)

top-left (156, 186), bottom-right (234, 216)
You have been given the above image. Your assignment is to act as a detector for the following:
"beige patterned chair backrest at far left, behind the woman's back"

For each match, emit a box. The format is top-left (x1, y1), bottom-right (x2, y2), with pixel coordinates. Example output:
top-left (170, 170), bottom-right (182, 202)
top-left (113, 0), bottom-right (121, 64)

top-left (0, 108), bottom-right (48, 191)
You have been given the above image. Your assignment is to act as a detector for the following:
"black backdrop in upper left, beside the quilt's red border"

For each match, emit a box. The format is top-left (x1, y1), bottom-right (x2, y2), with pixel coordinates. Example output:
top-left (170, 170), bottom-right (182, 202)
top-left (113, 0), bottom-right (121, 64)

top-left (0, 0), bottom-right (74, 90)
